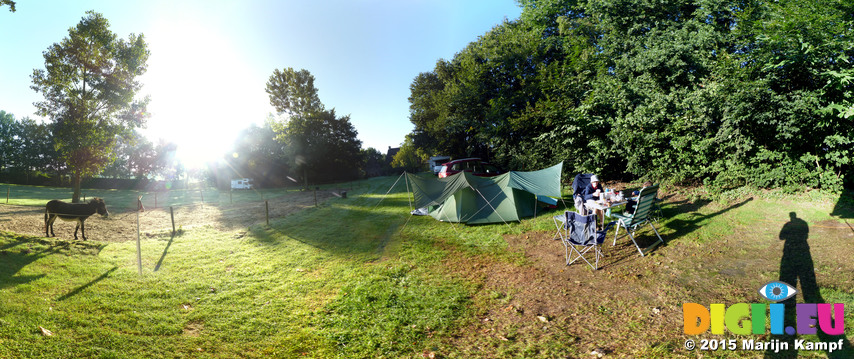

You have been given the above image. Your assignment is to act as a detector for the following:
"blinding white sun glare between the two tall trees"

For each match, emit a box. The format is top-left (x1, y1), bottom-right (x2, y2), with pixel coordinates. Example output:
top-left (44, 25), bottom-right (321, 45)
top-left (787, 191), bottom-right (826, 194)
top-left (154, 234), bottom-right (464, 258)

top-left (141, 15), bottom-right (271, 169)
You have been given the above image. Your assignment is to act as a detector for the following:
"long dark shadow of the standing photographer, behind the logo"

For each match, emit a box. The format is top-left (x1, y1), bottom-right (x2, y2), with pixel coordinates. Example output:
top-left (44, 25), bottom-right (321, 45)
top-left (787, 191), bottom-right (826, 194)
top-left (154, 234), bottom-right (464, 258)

top-left (765, 212), bottom-right (854, 358)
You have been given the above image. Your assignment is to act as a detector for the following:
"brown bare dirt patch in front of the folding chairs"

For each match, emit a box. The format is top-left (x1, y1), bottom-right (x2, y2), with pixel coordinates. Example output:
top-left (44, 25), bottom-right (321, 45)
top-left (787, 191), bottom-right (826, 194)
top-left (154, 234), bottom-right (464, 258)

top-left (448, 233), bottom-right (681, 356)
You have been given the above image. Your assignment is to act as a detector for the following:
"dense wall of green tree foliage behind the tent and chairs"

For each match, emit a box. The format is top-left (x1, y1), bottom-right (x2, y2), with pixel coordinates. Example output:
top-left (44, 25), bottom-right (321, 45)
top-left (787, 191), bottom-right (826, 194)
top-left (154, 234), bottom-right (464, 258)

top-left (410, 0), bottom-right (854, 190)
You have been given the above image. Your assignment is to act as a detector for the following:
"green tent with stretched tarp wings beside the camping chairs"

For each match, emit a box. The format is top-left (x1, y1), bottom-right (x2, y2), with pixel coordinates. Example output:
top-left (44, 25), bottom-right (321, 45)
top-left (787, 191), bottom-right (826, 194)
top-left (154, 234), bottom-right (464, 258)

top-left (406, 163), bottom-right (563, 224)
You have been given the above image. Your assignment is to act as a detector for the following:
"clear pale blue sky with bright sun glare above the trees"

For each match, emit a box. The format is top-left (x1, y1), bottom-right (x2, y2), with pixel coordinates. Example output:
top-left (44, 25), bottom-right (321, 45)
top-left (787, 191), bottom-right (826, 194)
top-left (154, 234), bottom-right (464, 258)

top-left (0, 0), bottom-right (521, 166)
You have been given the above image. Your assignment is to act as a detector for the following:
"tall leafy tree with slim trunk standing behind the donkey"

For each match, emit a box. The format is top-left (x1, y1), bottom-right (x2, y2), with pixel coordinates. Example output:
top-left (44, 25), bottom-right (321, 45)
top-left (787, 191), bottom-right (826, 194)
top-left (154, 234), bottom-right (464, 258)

top-left (31, 11), bottom-right (149, 202)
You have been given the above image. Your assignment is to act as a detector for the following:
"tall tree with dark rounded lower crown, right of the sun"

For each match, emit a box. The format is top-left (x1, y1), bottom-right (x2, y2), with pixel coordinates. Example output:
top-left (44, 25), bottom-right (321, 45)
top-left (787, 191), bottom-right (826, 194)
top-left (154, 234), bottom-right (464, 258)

top-left (267, 68), bottom-right (362, 186)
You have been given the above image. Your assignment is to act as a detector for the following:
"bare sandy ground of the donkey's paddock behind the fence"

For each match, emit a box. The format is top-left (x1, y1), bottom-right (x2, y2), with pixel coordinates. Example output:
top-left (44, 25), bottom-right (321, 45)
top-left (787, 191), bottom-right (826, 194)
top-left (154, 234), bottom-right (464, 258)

top-left (0, 191), bottom-right (334, 242)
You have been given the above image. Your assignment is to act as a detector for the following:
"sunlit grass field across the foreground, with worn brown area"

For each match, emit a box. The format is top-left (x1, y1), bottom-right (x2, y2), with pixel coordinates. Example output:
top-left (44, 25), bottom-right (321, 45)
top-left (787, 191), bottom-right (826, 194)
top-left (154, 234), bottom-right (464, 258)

top-left (0, 178), bottom-right (854, 358)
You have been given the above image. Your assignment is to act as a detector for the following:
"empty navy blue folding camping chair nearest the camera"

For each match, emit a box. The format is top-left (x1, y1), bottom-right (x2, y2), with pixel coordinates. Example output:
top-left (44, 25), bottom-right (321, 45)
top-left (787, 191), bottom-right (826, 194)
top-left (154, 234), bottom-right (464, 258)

top-left (554, 211), bottom-right (615, 270)
